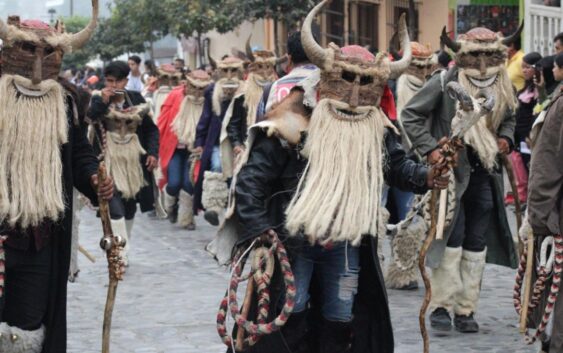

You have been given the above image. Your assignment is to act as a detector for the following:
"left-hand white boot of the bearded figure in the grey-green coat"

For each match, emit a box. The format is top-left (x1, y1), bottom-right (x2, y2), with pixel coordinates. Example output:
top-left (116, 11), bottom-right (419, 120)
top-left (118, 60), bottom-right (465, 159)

top-left (430, 247), bottom-right (462, 312)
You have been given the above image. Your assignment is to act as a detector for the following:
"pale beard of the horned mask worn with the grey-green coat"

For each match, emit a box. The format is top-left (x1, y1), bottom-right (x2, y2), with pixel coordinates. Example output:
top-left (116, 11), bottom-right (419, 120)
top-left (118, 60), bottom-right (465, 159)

top-left (458, 68), bottom-right (517, 171)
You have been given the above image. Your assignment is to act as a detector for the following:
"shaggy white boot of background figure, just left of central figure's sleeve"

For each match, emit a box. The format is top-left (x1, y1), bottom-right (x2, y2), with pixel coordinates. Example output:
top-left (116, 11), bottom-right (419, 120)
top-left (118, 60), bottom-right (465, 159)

top-left (201, 171), bottom-right (229, 226)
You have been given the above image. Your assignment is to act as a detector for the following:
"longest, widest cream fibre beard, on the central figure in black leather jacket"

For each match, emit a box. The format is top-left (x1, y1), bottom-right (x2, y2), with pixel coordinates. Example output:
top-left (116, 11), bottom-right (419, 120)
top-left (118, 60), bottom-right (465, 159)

top-left (286, 99), bottom-right (388, 245)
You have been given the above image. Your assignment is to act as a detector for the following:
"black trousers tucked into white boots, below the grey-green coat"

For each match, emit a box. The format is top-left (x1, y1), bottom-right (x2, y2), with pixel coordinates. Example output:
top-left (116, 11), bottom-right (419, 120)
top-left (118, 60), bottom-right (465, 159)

top-left (448, 170), bottom-right (494, 252)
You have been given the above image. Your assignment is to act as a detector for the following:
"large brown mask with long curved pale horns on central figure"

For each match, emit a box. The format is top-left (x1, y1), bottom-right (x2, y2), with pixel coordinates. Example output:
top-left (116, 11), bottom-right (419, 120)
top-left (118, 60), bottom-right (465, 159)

top-left (301, 0), bottom-right (412, 113)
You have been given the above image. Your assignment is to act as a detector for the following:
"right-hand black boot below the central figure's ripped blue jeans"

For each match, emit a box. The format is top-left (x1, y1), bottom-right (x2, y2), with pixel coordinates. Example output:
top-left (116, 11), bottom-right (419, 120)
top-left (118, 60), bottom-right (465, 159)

top-left (319, 319), bottom-right (352, 353)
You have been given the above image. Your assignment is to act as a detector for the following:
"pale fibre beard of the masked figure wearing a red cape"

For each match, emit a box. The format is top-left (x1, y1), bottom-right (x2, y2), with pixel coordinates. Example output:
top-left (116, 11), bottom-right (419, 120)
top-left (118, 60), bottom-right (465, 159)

top-left (172, 96), bottom-right (207, 148)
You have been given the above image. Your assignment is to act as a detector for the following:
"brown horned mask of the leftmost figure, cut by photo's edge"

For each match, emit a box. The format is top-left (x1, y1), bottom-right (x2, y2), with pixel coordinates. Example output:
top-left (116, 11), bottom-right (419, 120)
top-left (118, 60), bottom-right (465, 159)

top-left (0, 0), bottom-right (98, 85)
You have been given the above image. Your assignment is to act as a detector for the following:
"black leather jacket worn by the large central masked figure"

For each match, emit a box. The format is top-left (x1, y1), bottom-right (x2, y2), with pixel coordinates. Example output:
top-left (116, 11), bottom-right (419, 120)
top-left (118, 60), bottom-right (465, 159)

top-left (235, 130), bottom-right (428, 242)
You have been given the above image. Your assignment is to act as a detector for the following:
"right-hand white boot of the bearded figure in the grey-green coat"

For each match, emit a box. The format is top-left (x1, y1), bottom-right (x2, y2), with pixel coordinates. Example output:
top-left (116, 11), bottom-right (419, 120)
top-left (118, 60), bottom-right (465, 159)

top-left (454, 250), bottom-right (487, 316)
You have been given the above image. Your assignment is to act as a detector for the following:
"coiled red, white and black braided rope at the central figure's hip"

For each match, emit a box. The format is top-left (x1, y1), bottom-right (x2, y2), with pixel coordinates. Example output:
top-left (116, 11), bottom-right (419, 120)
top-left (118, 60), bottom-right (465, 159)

top-left (217, 232), bottom-right (296, 350)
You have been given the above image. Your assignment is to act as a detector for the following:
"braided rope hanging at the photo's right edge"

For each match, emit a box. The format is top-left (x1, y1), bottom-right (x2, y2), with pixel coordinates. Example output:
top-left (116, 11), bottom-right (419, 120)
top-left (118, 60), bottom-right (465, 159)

top-left (513, 235), bottom-right (563, 344)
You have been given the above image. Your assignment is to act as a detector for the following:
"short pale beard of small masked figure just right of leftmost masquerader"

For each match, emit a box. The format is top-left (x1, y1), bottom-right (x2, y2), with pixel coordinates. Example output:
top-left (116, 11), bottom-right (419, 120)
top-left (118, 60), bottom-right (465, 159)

top-left (105, 132), bottom-right (146, 199)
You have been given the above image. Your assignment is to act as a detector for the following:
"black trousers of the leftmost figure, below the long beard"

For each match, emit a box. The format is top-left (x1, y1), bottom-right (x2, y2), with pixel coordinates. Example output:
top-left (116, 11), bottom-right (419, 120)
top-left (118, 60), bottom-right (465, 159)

top-left (0, 245), bottom-right (52, 330)
